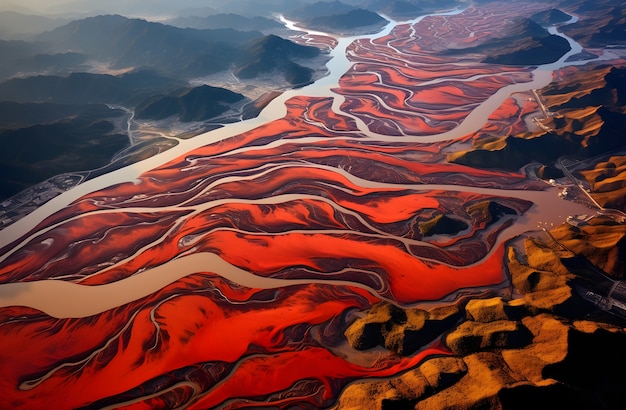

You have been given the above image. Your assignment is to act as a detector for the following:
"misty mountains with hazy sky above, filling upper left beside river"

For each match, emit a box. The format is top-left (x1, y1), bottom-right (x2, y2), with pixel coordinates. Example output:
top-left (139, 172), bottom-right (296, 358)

top-left (0, 0), bottom-right (442, 203)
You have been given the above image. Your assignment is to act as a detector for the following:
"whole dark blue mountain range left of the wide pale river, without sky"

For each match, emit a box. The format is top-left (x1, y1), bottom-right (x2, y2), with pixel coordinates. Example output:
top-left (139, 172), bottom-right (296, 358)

top-left (0, 10), bottom-right (320, 199)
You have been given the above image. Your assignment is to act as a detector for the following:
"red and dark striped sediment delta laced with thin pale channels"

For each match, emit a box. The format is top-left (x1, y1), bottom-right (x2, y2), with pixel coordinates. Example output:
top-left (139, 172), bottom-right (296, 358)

top-left (0, 3), bottom-right (596, 409)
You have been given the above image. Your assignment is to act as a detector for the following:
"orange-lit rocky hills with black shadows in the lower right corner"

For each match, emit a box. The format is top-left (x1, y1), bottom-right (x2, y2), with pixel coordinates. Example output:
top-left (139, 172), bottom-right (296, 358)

top-left (336, 218), bottom-right (626, 409)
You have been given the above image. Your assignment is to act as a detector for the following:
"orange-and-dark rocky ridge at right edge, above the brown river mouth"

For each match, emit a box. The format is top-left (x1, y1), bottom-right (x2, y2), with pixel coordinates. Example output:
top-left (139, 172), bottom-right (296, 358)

top-left (448, 65), bottom-right (626, 170)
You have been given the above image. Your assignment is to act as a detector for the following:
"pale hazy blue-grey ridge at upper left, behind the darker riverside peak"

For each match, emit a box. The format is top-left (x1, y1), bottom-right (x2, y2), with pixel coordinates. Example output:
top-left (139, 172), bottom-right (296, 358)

top-left (36, 15), bottom-right (262, 75)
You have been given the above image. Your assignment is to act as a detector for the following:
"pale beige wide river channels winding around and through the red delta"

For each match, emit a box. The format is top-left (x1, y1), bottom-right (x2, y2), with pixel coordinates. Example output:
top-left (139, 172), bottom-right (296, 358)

top-left (0, 10), bottom-right (590, 318)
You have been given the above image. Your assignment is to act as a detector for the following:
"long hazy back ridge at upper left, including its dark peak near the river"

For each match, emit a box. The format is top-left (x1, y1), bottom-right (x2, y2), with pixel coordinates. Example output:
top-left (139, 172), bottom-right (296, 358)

top-left (0, 15), bottom-right (326, 82)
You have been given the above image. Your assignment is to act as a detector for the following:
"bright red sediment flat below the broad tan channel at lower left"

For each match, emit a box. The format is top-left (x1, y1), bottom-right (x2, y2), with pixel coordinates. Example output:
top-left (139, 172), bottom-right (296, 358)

top-left (0, 275), bottom-right (446, 408)
